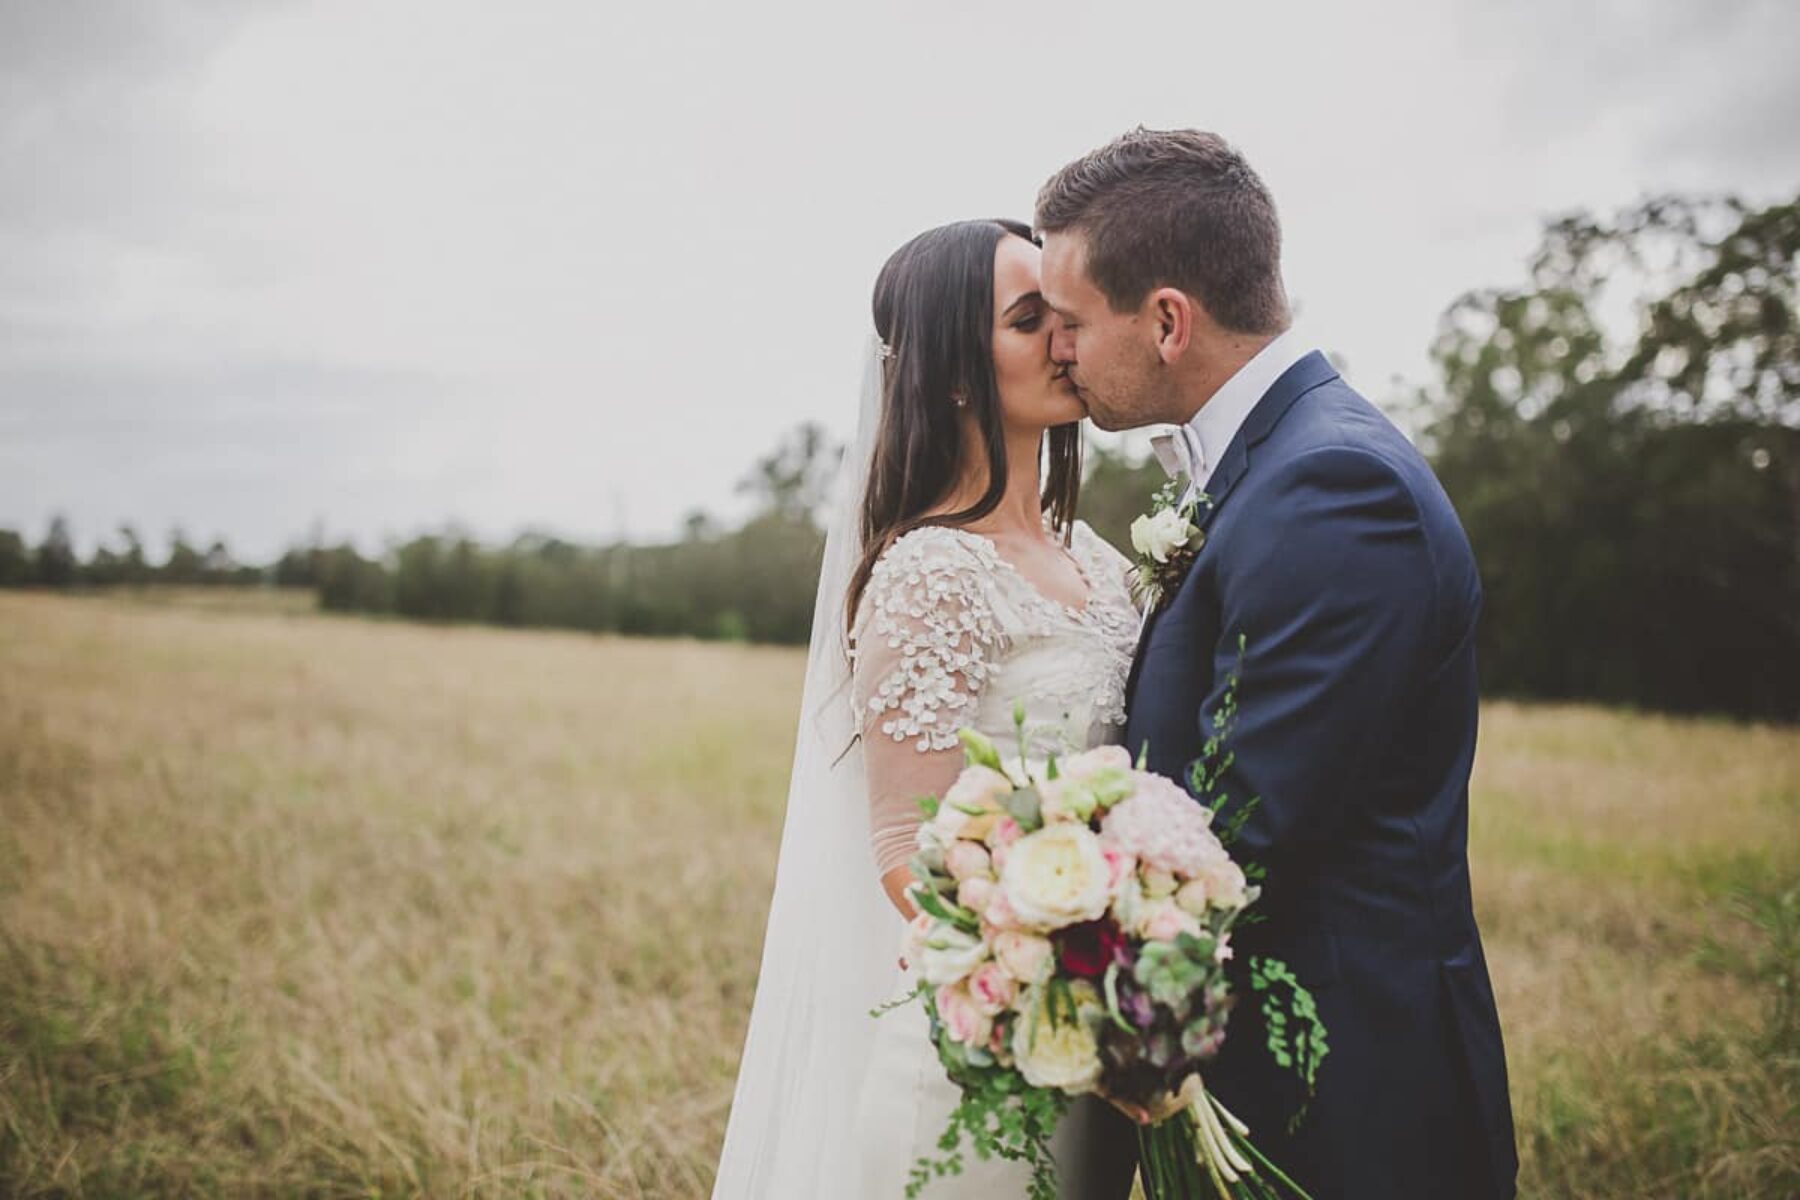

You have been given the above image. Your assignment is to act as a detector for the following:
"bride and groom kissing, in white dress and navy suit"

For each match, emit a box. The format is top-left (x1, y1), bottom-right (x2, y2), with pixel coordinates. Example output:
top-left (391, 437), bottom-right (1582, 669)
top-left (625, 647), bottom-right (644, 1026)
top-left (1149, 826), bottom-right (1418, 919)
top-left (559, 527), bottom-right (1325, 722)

top-left (713, 128), bottom-right (1517, 1200)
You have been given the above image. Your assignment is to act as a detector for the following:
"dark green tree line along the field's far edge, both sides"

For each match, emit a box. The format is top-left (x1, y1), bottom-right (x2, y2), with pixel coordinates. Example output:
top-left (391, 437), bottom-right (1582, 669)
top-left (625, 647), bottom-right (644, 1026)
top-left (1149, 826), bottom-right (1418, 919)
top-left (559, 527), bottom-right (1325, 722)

top-left (0, 196), bottom-right (1800, 720)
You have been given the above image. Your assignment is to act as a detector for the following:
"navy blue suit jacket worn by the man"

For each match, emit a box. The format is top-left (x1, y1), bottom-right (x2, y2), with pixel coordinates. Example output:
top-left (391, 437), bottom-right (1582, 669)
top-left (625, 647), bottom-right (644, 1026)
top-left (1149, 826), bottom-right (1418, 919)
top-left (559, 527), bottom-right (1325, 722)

top-left (1127, 353), bottom-right (1517, 1200)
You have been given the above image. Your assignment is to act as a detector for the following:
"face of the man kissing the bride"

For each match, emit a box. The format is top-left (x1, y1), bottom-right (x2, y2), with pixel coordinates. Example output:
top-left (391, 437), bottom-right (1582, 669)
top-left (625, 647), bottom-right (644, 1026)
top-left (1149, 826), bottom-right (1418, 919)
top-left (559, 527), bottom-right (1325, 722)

top-left (1042, 230), bottom-right (1168, 430)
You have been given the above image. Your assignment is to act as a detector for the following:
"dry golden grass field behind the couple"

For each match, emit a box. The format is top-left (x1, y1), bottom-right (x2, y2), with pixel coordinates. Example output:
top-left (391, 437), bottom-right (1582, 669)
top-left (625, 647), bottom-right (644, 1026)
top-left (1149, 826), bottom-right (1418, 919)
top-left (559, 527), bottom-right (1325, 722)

top-left (0, 594), bottom-right (1800, 1200)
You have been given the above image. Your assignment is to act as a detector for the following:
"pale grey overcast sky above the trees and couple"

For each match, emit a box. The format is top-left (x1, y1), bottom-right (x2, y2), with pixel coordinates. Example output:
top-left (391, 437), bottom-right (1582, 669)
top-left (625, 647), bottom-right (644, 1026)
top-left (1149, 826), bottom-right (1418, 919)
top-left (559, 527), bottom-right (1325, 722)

top-left (0, 0), bottom-right (1800, 560)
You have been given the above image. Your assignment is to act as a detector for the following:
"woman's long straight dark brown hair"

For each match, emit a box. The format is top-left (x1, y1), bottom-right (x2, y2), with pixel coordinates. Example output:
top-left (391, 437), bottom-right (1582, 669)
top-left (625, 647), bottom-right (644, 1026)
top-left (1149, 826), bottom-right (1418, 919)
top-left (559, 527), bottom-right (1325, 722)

top-left (844, 219), bottom-right (1082, 644)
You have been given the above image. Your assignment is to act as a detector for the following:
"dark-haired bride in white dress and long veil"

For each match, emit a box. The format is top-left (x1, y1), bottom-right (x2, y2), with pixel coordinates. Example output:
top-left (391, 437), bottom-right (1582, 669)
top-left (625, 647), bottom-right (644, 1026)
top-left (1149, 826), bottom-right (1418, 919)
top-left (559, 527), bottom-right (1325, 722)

top-left (713, 221), bottom-right (1138, 1200)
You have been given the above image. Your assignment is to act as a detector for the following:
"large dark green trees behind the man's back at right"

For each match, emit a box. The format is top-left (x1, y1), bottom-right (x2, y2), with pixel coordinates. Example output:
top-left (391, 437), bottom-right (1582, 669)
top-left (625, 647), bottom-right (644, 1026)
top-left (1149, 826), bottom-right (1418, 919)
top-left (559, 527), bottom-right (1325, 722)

top-left (1420, 198), bottom-right (1800, 720)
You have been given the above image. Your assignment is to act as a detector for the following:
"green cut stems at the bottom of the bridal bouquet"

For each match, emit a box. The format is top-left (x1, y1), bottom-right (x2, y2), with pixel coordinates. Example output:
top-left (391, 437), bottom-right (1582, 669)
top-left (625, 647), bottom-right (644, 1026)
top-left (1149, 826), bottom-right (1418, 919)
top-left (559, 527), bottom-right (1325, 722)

top-left (1138, 1090), bottom-right (1312, 1200)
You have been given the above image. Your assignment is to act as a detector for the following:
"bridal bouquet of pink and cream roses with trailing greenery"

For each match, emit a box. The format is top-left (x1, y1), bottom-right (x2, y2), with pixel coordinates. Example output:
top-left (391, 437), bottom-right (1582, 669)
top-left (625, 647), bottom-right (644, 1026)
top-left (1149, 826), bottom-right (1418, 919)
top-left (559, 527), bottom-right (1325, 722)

top-left (877, 698), bottom-right (1325, 1200)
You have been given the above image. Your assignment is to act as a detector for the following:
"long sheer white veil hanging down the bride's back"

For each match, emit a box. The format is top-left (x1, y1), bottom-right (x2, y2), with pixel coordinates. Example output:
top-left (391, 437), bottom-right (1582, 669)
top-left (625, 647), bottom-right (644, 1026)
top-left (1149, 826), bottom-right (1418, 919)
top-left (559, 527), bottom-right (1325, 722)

top-left (713, 338), bottom-right (902, 1200)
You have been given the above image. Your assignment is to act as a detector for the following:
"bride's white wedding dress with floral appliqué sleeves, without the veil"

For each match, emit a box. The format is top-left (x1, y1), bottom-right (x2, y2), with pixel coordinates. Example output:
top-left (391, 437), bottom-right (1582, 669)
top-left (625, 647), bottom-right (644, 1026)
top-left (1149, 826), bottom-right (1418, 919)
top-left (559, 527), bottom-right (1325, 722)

top-left (850, 522), bottom-right (1138, 1200)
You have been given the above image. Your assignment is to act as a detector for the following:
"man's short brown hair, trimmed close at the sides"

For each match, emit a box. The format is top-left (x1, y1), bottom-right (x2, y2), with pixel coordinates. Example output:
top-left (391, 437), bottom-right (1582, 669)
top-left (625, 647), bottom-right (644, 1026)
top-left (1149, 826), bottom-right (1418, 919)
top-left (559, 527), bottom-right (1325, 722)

top-left (1037, 126), bottom-right (1289, 333)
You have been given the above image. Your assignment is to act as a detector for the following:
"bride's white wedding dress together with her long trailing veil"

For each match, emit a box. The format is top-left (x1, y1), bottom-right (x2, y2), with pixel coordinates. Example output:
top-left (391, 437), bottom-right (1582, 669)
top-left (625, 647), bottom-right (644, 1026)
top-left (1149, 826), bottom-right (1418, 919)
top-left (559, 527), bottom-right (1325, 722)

top-left (713, 336), bottom-right (1138, 1200)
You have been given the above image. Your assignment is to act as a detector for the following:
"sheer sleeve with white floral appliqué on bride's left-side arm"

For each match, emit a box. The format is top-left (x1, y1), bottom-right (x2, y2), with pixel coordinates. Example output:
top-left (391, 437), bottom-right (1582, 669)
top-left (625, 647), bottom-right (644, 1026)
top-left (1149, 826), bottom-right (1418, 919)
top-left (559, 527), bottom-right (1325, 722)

top-left (851, 529), bottom-right (1001, 874)
